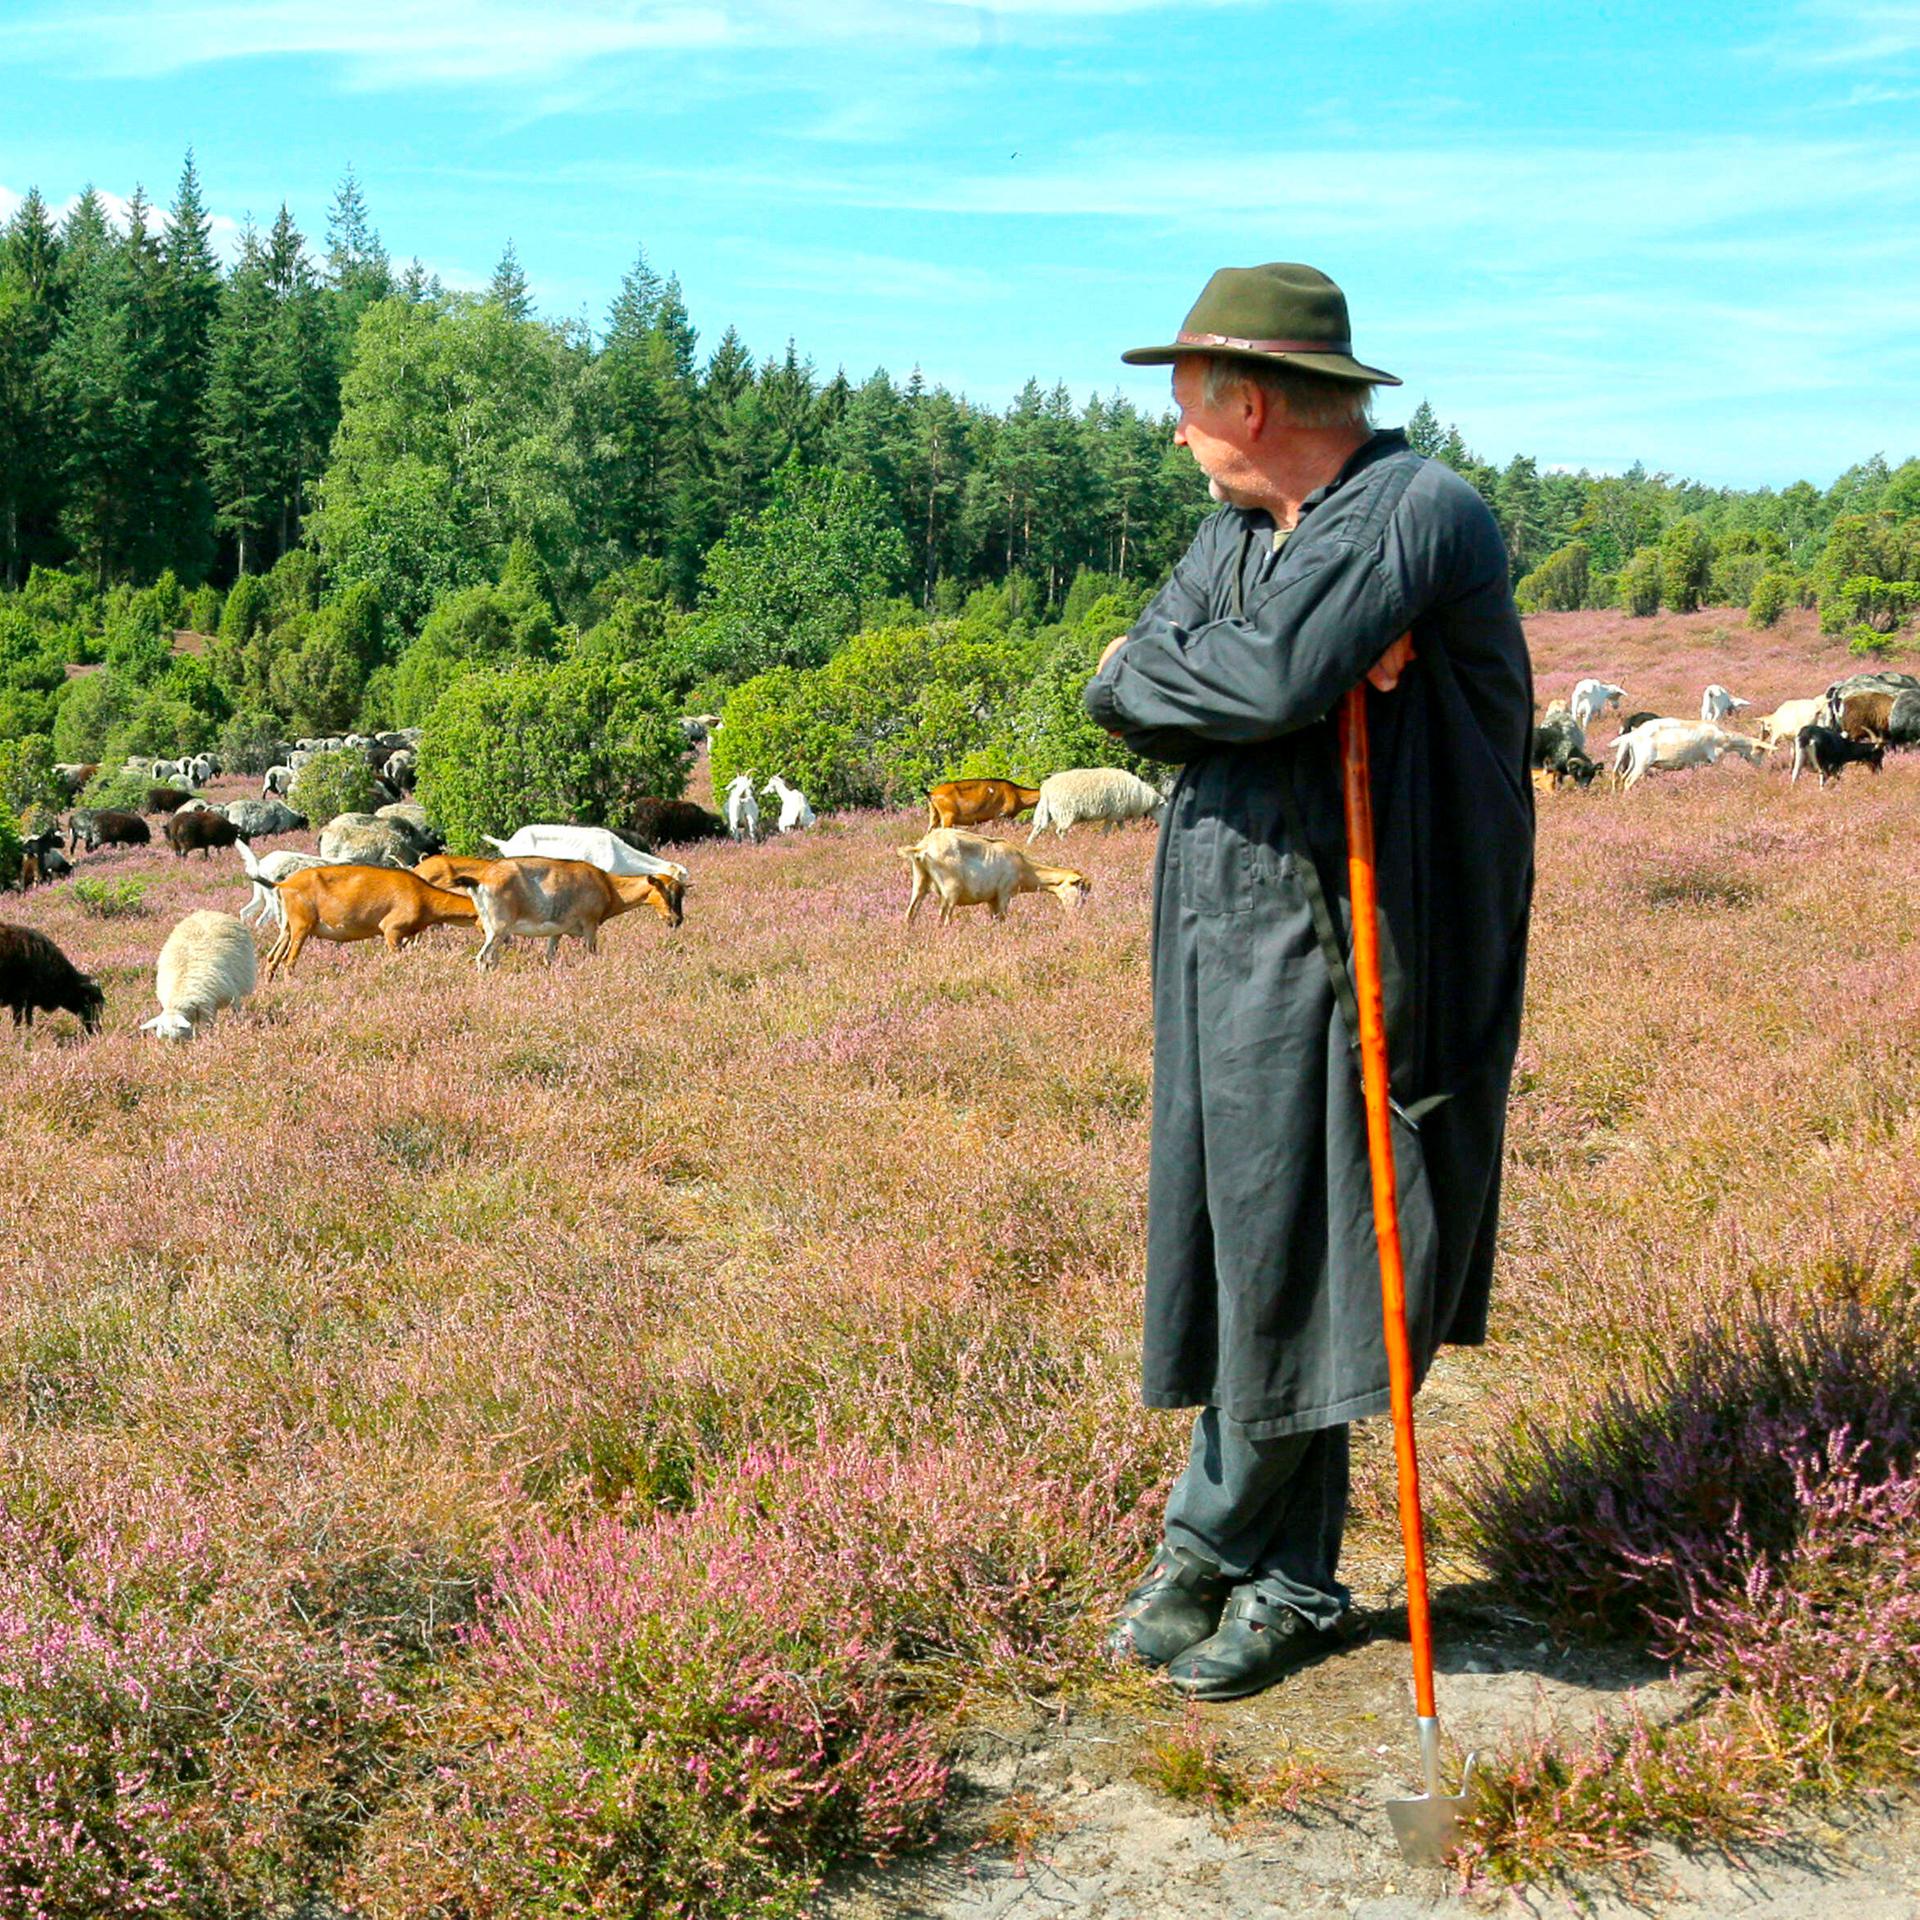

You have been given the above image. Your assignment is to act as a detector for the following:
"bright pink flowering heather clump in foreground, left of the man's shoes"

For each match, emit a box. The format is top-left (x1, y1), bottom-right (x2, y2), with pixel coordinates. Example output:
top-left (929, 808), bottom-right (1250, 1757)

top-left (355, 1442), bottom-right (1144, 1916)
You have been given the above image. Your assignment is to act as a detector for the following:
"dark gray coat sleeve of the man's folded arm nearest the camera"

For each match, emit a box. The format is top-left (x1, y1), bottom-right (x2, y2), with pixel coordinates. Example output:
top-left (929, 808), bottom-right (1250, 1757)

top-left (1087, 543), bottom-right (1430, 760)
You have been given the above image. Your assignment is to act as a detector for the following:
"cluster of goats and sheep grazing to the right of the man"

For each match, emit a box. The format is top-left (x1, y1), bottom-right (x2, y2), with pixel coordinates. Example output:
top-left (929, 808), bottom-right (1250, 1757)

top-left (1534, 672), bottom-right (1920, 791)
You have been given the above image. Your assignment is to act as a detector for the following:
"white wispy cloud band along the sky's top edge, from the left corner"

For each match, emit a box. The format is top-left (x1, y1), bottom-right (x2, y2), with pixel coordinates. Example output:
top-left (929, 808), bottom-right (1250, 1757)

top-left (0, 0), bottom-right (1246, 90)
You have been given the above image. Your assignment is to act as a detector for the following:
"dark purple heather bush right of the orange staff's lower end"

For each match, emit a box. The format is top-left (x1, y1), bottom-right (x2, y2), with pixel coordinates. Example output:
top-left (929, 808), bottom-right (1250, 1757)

top-left (1459, 1306), bottom-right (1920, 1649)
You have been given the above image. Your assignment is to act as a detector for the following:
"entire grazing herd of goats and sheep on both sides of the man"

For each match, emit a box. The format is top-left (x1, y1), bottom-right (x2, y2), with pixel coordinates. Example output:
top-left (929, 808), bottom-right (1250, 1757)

top-left (0, 672), bottom-right (1920, 1041)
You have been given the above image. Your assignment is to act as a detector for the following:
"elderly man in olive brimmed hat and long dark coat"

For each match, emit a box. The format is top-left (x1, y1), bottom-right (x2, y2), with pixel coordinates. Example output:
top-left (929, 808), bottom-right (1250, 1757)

top-left (1087, 265), bottom-right (1532, 1699)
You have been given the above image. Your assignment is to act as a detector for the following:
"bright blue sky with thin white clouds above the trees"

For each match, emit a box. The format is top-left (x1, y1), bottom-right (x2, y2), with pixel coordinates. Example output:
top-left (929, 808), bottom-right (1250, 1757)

top-left (0, 0), bottom-right (1920, 486)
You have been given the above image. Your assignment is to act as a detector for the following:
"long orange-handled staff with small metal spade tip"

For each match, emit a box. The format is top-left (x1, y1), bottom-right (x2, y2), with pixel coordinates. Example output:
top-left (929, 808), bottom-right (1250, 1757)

top-left (1340, 682), bottom-right (1475, 1866)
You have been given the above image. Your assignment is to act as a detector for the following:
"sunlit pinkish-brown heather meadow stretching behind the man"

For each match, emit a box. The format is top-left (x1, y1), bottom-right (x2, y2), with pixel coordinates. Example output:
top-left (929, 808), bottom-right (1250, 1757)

top-left (0, 614), bottom-right (1920, 1916)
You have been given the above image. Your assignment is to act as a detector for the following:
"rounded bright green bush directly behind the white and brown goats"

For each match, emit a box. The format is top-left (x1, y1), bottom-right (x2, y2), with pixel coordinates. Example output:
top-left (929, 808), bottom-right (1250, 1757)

top-left (416, 660), bottom-right (693, 852)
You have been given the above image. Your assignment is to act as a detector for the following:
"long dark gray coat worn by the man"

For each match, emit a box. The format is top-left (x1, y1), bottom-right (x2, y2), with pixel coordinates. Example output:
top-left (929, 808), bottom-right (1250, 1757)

top-left (1087, 432), bottom-right (1534, 1436)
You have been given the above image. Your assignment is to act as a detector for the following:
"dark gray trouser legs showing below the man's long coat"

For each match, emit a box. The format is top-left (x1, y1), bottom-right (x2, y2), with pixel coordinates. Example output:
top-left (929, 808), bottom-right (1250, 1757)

top-left (1165, 1407), bottom-right (1352, 1626)
